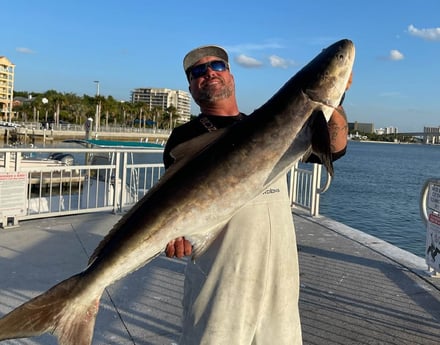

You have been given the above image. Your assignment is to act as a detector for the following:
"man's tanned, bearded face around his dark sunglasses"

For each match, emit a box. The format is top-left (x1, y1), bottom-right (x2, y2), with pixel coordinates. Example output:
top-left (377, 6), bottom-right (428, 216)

top-left (189, 56), bottom-right (235, 105)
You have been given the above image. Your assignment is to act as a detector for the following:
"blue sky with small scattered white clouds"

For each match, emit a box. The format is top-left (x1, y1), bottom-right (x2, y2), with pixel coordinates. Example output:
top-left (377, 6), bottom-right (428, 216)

top-left (0, 0), bottom-right (440, 132)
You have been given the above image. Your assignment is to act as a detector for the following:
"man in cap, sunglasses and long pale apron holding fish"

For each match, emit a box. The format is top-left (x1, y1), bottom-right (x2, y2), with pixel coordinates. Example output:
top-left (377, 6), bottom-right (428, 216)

top-left (164, 46), bottom-right (347, 345)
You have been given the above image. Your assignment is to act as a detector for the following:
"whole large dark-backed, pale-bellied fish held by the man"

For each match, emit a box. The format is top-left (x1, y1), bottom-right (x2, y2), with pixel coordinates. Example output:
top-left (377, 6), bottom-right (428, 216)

top-left (0, 40), bottom-right (355, 345)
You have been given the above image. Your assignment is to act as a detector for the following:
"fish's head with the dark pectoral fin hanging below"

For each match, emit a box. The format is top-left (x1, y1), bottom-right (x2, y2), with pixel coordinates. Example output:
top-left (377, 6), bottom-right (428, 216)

top-left (278, 39), bottom-right (355, 175)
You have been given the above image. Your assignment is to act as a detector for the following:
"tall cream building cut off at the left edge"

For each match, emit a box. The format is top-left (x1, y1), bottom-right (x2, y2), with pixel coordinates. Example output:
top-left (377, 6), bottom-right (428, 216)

top-left (0, 56), bottom-right (15, 122)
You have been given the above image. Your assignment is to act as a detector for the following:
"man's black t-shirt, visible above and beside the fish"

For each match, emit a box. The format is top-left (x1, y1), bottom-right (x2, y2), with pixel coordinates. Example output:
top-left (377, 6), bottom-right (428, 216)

top-left (163, 113), bottom-right (346, 168)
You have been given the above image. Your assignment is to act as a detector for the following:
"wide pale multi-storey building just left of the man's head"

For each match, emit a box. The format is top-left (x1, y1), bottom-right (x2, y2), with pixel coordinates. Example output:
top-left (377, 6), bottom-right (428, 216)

top-left (131, 88), bottom-right (191, 123)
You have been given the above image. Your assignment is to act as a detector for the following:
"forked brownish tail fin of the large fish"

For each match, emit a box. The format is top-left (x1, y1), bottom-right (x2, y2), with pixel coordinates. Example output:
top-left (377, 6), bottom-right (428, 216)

top-left (0, 274), bottom-right (101, 345)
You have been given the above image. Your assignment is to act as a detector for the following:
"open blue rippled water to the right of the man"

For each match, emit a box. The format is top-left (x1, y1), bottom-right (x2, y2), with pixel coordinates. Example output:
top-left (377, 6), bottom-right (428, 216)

top-left (320, 142), bottom-right (440, 257)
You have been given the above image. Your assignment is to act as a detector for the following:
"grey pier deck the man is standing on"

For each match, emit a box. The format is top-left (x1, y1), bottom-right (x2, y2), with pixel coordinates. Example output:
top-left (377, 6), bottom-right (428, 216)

top-left (0, 209), bottom-right (440, 345)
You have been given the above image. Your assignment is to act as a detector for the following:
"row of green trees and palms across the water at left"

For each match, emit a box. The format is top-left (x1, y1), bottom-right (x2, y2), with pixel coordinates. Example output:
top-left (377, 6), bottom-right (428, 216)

top-left (13, 90), bottom-right (184, 129)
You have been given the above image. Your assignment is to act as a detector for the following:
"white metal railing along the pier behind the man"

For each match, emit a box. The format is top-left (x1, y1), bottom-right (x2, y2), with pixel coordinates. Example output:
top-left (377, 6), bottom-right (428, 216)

top-left (0, 147), bottom-right (330, 227)
